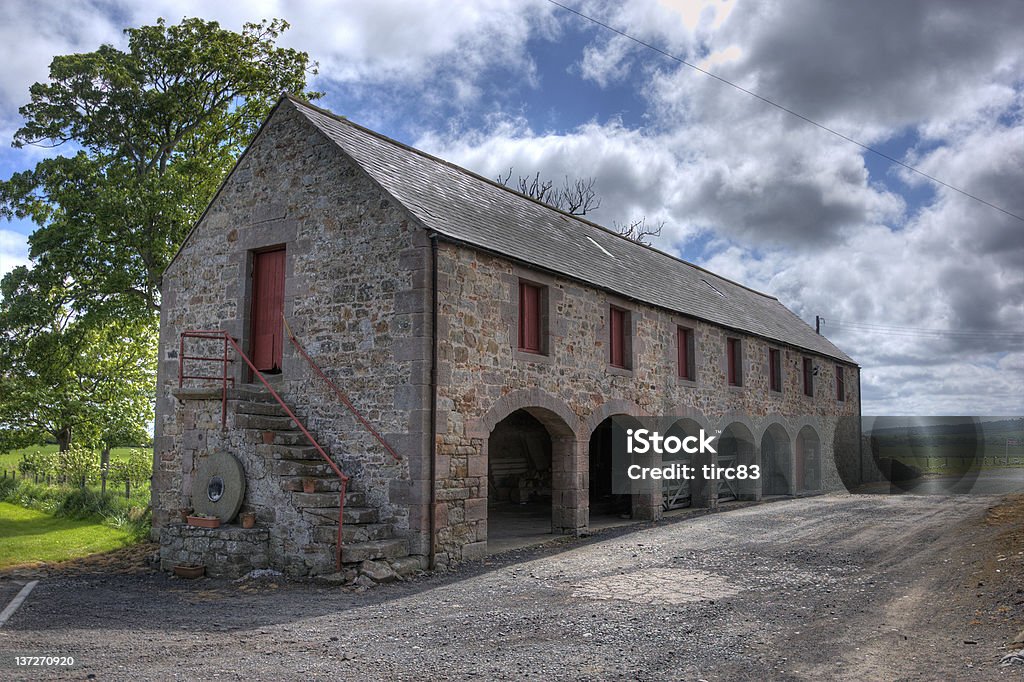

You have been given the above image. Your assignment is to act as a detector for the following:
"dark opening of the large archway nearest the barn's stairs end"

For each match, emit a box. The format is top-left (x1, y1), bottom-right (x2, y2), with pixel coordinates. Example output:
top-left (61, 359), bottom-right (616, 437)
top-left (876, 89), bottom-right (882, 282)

top-left (487, 410), bottom-right (551, 511)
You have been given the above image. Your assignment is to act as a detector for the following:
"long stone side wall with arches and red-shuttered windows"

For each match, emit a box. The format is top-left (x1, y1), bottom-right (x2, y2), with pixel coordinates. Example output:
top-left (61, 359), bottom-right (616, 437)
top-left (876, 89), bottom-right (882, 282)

top-left (436, 242), bottom-right (859, 562)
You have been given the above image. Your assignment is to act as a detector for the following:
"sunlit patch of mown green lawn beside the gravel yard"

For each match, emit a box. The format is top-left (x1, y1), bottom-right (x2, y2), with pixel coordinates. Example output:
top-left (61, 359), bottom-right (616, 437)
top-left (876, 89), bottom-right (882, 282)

top-left (0, 502), bottom-right (131, 568)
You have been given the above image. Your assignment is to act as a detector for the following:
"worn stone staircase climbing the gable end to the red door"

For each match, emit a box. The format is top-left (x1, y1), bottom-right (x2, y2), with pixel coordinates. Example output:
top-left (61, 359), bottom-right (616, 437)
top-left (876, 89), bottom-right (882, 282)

top-left (234, 387), bottom-right (411, 582)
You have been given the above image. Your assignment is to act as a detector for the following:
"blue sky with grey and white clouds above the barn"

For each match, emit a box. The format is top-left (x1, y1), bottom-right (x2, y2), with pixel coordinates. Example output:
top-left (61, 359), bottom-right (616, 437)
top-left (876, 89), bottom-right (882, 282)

top-left (0, 0), bottom-right (1024, 415)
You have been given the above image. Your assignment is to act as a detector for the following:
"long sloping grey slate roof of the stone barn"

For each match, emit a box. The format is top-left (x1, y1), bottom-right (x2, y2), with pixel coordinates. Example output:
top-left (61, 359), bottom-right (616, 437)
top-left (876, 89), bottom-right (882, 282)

top-left (289, 97), bottom-right (854, 363)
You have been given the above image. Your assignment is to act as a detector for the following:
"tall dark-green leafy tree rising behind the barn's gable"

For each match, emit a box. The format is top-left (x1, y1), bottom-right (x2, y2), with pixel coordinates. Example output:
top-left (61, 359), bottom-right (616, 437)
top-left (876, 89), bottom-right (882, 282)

top-left (0, 18), bottom-right (317, 316)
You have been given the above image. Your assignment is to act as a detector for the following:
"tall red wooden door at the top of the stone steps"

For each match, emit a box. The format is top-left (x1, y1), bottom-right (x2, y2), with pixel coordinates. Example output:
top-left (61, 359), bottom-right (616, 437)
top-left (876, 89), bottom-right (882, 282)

top-left (249, 249), bottom-right (285, 372)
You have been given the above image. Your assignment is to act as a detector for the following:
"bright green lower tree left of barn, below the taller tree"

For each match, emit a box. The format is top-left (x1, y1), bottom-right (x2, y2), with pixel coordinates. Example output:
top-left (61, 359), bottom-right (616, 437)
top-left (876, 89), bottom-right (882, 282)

top-left (0, 266), bottom-right (157, 452)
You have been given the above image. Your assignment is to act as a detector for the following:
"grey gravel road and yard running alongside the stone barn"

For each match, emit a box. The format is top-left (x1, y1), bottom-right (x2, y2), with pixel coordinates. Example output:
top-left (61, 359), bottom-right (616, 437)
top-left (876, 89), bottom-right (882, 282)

top-left (0, 495), bottom-right (1024, 680)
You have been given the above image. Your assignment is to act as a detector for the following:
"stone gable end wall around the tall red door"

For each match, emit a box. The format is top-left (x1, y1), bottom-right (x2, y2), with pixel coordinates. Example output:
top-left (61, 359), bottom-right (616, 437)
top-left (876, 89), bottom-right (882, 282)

top-left (153, 100), bottom-right (430, 553)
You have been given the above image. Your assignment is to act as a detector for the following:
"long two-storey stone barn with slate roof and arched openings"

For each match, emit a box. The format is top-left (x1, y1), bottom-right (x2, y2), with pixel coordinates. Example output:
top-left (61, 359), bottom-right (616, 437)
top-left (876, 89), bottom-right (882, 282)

top-left (153, 97), bottom-right (860, 580)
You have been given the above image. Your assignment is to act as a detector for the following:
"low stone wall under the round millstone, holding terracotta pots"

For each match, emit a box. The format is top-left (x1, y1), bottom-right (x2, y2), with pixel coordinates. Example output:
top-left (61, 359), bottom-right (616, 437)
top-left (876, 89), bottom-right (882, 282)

top-left (160, 523), bottom-right (270, 579)
